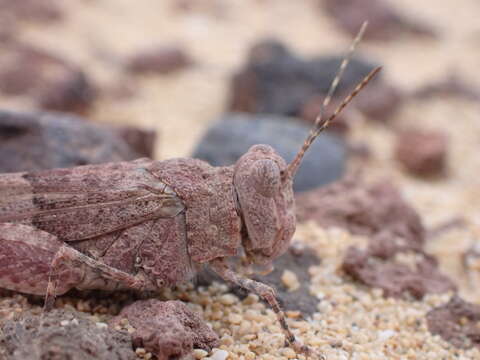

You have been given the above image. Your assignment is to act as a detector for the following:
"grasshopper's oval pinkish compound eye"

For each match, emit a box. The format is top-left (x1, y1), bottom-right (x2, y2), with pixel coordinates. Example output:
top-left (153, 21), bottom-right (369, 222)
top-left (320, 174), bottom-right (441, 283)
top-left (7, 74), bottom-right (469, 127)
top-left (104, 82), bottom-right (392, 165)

top-left (252, 159), bottom-right (281, 198)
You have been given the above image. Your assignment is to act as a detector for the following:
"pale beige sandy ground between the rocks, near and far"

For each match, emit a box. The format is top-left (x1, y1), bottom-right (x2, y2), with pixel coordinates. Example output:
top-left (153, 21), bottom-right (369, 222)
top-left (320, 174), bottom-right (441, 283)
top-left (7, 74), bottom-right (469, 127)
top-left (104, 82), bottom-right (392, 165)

top-left (0, 0), bottom-right (480, 360)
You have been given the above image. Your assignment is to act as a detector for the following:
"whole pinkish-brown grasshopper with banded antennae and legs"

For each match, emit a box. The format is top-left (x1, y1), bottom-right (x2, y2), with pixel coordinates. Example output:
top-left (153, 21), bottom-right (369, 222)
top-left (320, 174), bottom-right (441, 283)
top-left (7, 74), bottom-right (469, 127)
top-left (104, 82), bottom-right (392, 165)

top-left (0, 24), bottom-right (380, 356)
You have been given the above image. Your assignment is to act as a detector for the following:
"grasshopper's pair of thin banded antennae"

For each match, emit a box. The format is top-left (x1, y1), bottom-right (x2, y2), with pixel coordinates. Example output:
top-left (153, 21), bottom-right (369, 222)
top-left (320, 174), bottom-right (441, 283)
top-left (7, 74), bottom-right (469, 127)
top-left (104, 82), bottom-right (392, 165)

top-left (285, 21), bottom-right (381, 178)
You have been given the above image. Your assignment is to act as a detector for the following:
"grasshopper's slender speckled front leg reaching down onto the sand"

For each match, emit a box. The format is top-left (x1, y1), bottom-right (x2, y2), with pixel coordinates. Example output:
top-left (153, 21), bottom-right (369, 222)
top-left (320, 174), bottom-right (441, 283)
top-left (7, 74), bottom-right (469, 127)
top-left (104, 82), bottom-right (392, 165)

top-left (210, 259), bottom-right (325, 359)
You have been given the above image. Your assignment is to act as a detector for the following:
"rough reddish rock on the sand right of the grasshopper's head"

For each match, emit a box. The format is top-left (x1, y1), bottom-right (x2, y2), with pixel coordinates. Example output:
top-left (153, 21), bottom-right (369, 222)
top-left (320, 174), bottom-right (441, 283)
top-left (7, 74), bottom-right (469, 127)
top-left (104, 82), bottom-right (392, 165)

top-left (296, 177), bottom-right (455, 299)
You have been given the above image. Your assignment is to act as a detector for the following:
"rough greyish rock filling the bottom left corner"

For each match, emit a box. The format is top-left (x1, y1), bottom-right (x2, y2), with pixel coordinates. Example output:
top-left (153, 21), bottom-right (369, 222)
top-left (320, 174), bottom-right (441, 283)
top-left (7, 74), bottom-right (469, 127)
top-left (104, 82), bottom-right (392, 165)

top-left (0, 310), bottom-right (136, 360)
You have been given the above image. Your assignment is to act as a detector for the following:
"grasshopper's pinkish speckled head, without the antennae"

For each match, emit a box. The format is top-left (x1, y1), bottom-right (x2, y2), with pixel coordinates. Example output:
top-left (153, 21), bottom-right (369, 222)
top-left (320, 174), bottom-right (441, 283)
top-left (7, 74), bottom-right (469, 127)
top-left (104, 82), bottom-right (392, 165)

top-left (233, 145), bottom-right (295, 266)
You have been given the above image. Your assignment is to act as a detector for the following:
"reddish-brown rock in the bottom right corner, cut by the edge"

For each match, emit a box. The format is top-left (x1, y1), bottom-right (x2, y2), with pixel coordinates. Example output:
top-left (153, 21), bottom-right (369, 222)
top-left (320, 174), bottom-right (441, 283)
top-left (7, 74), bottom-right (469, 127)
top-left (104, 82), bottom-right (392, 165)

top-left (427, 296), bottom-right (480, 349)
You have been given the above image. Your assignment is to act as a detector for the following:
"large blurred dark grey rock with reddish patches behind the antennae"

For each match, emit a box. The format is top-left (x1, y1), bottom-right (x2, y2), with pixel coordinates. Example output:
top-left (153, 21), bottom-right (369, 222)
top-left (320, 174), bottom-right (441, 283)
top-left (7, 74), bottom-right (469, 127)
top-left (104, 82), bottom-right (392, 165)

top-left (229, 40), bottom-right (401, 121)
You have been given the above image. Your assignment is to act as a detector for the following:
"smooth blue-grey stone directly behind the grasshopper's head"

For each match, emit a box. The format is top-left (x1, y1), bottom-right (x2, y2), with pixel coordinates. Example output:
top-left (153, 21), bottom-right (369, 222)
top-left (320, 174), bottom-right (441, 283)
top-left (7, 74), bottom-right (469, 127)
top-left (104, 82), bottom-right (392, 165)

top-left (193, 114), bottom-right (346, 191)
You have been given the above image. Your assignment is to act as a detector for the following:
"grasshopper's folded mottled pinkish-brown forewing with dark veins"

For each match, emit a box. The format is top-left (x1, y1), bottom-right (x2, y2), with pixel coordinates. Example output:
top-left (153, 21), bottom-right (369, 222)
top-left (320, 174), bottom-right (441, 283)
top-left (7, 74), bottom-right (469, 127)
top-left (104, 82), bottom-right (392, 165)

top-left (0, 160), bottom-right (184, 241)
